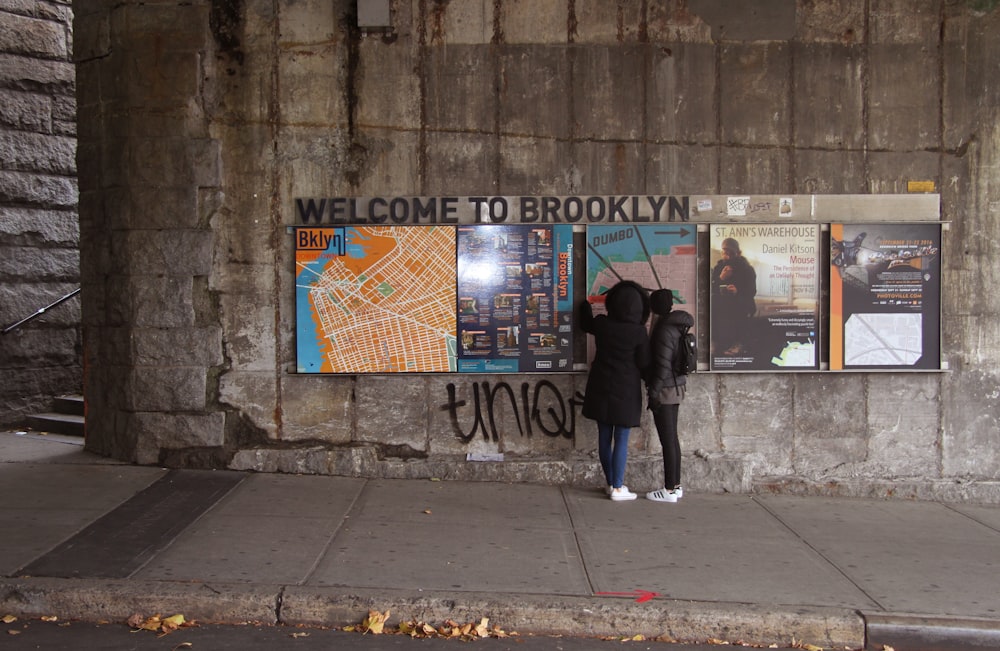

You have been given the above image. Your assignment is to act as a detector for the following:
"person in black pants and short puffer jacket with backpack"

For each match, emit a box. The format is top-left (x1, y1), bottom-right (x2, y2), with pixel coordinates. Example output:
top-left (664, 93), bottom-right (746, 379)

top-left (645, 289), bottom-right (694, 502)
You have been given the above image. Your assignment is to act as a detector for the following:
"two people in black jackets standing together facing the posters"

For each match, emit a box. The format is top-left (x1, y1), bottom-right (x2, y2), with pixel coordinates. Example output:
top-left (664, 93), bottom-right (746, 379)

top-left (578, 280), bottom-right (694, 502)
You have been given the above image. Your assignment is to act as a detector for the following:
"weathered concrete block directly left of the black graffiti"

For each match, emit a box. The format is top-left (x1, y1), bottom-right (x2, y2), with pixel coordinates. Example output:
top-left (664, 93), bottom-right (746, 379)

top-left (354, 375), bottom-right (430, 452)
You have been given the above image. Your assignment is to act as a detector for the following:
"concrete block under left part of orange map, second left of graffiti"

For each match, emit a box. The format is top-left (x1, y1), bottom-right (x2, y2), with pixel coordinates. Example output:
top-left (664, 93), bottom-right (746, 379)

top-left (281, 375), bottom-right (354, 444)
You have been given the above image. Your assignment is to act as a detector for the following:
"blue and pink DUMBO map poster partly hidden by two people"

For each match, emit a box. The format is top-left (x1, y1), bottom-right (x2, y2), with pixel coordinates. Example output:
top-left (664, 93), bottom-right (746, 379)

top-left (587, 223), bottom-right (698, 356)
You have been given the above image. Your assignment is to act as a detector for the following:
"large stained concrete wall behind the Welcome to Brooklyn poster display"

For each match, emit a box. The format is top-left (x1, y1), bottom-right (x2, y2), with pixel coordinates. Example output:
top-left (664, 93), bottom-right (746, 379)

top-left (76, 0), bottom-right (1000, 502)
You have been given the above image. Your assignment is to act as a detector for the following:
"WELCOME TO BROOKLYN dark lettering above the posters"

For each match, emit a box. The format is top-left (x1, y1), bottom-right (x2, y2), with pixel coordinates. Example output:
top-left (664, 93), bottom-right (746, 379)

top-left (295, 195), bottom-right (691, 225)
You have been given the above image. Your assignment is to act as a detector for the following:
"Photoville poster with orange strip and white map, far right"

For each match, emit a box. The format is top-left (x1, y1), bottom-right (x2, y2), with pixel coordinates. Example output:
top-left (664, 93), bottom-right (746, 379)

top-left (830, 223), bottom-right (941, 370)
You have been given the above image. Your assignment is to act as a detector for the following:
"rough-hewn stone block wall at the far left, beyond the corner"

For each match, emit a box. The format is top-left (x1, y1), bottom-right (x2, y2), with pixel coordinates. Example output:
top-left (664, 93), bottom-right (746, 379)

top-left (0, 0), bottom-right (83, 427)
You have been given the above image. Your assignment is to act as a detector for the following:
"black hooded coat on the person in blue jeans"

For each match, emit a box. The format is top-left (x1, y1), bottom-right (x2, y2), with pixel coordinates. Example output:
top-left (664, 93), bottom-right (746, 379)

top-left (578, 280), bottom-right (649, 427)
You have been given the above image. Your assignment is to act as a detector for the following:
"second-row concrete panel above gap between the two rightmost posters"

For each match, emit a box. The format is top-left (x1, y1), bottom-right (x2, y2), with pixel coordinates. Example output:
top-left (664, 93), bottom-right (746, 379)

top-left (792, 44), bottom-right (865, 150)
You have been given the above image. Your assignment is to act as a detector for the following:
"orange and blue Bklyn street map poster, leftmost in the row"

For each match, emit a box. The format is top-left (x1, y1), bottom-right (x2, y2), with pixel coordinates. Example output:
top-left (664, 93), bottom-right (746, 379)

top-left (294, 226), bottom-right (456, 373)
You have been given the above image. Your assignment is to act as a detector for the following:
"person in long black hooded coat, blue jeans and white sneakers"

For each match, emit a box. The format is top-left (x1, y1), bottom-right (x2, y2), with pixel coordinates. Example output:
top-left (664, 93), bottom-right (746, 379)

top-left (578, 280), bottom-right (649, 501)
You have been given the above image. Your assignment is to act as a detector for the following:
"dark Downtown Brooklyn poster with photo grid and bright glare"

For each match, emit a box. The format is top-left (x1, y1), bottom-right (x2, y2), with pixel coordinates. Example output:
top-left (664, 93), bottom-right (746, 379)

top-left (453, 224), bottom-right (573, 373)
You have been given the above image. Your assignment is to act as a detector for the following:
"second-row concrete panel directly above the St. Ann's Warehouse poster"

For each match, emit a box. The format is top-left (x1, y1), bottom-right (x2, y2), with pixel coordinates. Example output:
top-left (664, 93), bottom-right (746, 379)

top-left (719, 42), bottom-right (792, 148)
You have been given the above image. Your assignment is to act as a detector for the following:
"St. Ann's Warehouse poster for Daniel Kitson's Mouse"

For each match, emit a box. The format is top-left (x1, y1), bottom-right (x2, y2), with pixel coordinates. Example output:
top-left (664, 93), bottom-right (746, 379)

top-left (709, 224), bottom-right (820, 371)
